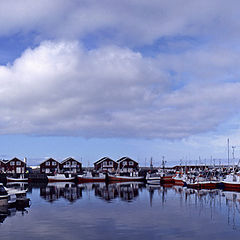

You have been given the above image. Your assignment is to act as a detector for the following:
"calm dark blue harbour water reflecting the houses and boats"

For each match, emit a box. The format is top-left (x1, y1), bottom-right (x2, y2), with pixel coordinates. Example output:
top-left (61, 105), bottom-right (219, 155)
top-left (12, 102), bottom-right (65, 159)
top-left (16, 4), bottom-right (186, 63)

top-left (0, 183), bottom-right (240, 240)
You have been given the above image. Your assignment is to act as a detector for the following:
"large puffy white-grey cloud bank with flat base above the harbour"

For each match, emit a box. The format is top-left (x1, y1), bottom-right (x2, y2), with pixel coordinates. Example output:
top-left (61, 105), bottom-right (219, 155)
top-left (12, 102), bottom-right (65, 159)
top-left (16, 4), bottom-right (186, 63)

top-left (0, 41), bottom-right (240, 139)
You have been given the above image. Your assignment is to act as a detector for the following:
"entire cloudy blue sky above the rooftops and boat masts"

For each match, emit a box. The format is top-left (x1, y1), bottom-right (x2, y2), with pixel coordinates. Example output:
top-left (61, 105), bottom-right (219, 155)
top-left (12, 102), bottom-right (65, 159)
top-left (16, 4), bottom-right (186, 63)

top-left (0, 0), bottom-right (240, 166)
